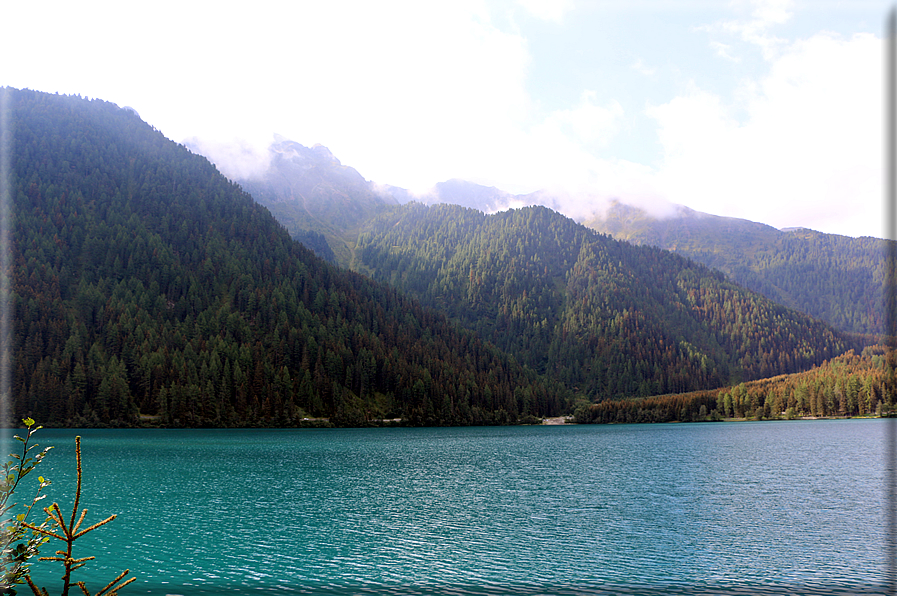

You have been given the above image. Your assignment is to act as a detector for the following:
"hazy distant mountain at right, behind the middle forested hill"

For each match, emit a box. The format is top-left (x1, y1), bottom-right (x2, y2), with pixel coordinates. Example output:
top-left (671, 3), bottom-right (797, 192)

top-left (583, 203), bottom-right (885, 335)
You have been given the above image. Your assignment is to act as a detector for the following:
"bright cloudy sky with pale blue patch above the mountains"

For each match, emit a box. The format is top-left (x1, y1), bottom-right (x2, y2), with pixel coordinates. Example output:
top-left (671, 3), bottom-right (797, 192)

top-left (0, 0), bottom-right (892, 237)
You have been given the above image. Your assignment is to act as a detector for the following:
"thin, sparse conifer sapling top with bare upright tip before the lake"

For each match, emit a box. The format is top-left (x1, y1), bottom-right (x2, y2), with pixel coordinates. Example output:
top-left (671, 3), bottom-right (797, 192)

top-left (22, 437), bottom-right (137, 596)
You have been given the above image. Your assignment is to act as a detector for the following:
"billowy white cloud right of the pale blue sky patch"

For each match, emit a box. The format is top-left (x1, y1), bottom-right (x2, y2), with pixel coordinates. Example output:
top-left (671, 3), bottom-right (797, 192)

top-left (648, 34), bottom-right (882, 235)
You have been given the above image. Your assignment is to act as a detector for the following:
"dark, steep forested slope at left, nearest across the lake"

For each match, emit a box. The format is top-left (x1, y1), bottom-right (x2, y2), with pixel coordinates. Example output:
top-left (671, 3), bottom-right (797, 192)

top-left (4, 89), bottom-right (567, 426)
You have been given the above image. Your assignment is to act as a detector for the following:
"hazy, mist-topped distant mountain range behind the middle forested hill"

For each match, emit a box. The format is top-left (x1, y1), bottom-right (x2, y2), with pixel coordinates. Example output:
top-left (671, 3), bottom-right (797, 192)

top-left (191, 139), bottom-right (884, 334)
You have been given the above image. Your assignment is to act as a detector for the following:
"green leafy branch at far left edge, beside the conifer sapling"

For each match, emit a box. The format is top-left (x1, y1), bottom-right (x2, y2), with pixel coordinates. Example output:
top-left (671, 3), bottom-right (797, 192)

top-left (0, 418), bottom-right (52, 594)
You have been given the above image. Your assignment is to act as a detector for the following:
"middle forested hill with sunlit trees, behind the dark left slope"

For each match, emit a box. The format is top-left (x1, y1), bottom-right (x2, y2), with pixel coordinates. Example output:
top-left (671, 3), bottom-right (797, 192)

top-left (356, 204), bottom-right (847, 400)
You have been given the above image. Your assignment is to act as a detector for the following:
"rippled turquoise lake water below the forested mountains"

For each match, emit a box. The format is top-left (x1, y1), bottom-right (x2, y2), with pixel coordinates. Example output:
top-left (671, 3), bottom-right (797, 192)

top-left (6, 420), bottom-right (888, 596)
